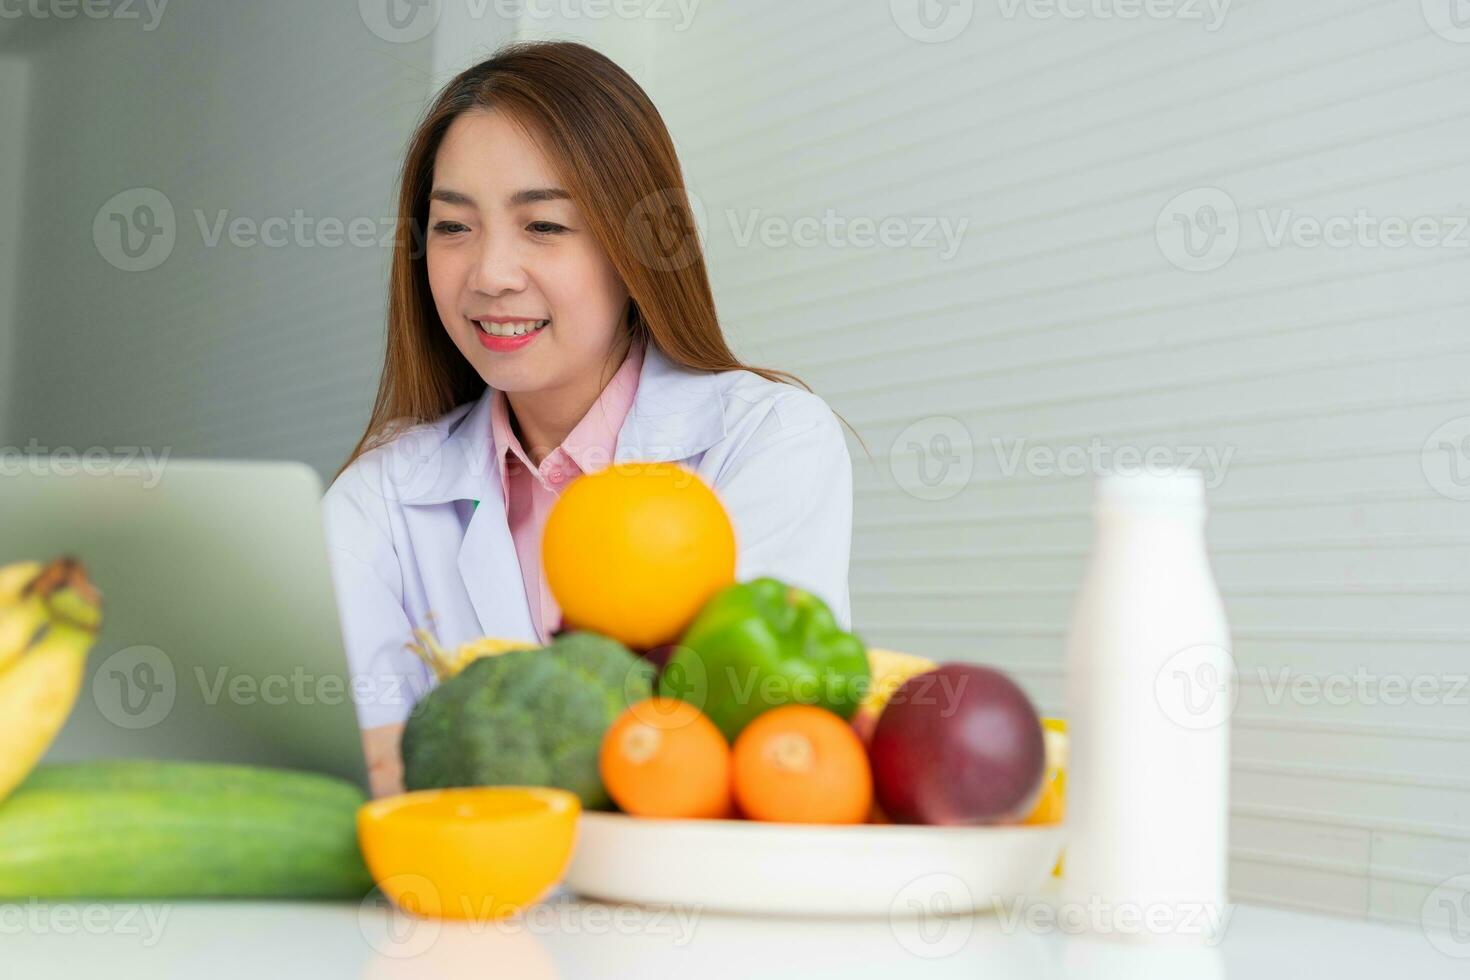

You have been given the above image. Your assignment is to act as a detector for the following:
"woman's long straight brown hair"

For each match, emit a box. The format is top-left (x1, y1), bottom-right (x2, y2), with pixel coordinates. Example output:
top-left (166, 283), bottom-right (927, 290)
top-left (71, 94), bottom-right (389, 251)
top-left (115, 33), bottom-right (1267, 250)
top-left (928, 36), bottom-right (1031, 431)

top-left (334, 41), bottom-right (861, 479)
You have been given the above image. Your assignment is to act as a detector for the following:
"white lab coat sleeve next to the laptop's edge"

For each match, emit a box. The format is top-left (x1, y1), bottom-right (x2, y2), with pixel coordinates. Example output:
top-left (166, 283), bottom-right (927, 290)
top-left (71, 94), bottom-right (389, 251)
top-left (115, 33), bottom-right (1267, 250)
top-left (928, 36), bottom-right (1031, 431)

top-left (322, 475), bottom-right (431, 729)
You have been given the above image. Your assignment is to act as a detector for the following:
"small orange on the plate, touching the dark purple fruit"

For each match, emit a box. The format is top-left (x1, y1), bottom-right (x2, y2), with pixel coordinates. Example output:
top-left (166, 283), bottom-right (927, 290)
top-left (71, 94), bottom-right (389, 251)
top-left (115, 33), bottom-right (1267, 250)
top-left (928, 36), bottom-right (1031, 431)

top-left (734, 704), bottom-right (873, 823)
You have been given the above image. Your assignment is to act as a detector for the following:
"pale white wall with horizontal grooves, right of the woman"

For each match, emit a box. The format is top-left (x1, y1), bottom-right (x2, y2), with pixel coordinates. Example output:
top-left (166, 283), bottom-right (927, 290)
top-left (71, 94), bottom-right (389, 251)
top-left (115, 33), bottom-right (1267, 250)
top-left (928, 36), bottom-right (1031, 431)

top-left (549, 0), bottom-right (1470, 923)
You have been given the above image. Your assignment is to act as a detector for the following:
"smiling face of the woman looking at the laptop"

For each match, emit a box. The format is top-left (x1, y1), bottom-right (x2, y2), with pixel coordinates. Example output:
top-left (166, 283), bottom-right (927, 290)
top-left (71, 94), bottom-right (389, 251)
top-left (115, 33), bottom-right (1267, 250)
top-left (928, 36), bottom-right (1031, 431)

top-left (426, 110), bottom-right (628, 392)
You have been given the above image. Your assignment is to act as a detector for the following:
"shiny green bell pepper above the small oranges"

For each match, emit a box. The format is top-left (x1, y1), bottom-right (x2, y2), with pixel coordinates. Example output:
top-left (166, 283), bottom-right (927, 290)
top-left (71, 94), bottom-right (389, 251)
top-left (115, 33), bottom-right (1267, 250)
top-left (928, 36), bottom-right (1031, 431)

top-left (659, 577), bottom-right (869, 742)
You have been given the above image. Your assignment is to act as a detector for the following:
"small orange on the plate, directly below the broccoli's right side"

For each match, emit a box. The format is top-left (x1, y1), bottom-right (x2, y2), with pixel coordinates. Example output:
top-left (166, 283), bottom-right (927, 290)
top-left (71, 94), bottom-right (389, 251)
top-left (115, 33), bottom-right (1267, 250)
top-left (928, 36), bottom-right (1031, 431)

top-left (600, 698), bottom-right (731, 818)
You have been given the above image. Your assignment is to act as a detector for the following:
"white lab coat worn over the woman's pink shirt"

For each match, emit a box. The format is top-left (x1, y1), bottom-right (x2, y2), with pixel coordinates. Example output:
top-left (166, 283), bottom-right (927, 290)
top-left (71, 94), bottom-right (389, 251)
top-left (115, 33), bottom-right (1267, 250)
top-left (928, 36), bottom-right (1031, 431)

top-left (322, 341), bottom-right (853, 729)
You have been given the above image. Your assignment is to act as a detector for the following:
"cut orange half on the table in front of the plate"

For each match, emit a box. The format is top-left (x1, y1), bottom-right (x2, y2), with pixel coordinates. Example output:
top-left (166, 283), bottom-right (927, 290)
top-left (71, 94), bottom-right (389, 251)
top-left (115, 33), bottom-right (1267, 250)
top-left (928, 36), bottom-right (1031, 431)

top-left (357, 786), bottom-right (582, 922)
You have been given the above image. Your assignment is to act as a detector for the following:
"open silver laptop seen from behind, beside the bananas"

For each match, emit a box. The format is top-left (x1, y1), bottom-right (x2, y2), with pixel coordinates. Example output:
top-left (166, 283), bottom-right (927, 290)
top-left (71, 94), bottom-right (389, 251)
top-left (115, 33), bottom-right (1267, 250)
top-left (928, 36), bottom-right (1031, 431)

top-left (0, 457), bottom-right (368, 789)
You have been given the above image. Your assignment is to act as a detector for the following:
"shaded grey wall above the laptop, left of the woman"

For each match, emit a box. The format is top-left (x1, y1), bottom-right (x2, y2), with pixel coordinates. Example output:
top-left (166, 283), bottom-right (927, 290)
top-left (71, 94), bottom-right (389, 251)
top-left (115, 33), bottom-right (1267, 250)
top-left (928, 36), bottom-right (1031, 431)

top-left (0, 0), bottom-right (432, 478)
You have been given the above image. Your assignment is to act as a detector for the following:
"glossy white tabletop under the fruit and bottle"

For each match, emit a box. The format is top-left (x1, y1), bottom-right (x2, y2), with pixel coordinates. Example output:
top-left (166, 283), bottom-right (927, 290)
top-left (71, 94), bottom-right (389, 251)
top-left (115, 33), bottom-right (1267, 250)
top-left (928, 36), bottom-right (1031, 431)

top-left (0, 893), bottom-right (1470, 980)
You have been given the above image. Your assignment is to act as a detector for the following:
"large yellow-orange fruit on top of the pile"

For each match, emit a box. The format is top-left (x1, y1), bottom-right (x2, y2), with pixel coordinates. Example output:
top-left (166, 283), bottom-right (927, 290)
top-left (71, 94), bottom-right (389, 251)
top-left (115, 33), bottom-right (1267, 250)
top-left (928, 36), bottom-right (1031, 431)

top-left (541, 463), bottom-right (735, 649)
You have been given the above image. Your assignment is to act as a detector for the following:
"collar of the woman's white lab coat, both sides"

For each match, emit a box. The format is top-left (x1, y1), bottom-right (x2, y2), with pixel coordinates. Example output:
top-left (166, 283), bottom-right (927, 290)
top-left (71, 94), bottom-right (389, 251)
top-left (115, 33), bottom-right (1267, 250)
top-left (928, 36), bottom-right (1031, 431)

top-left (392, 338), bottom-right (725, 504)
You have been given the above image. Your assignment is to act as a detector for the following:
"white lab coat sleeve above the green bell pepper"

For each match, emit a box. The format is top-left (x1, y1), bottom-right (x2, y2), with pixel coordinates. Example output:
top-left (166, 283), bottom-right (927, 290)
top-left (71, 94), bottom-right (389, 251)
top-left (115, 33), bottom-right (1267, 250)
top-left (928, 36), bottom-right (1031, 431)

top-left (714, 389), bottom-right (853, 630)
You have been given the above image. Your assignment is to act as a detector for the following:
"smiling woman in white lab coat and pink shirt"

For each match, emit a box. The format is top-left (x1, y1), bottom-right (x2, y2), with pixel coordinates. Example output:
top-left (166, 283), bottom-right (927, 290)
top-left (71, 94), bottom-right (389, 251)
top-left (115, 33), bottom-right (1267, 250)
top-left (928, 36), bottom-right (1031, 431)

top-left (323, 43), bottom-right (853, 795)
